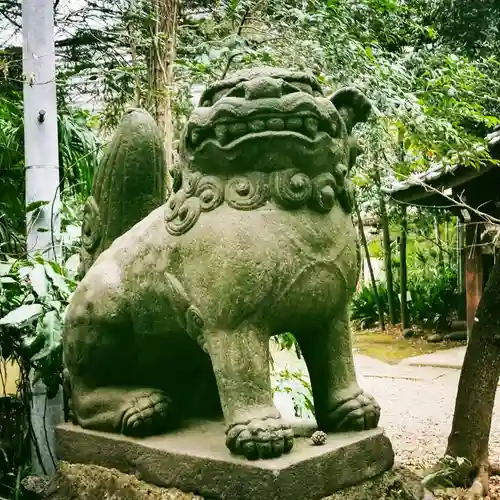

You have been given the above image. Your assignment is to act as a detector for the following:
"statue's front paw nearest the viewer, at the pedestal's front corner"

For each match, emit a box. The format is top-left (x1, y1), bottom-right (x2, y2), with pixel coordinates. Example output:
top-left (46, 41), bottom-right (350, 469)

top-left (226, 418), bottom-right (293, 460)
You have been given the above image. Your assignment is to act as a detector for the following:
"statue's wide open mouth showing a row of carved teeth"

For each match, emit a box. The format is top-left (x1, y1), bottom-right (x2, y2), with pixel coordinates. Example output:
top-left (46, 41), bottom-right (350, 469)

top-left (188, 113), bottom-right (333, 148)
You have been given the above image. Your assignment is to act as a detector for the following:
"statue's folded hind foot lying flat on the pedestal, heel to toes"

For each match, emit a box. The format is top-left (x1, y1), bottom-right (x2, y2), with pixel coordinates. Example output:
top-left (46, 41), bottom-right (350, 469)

top-left (71, 381), bottom-right (174, 436)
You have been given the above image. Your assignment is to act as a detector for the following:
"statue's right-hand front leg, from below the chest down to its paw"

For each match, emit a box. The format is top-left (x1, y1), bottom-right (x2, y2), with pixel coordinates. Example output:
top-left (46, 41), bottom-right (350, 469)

top-left (296, 311), bottom-right (380, 432)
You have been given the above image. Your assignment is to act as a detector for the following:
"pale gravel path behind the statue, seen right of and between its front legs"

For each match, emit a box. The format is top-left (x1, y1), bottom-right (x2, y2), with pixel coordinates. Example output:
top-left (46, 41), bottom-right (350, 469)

top-left (273, 344), bottom-right (500, 467)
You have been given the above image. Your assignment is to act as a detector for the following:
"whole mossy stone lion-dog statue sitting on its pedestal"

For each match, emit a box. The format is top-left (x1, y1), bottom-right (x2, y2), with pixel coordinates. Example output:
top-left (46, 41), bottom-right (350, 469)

top-left (64, 68), bottom-right (380, 459)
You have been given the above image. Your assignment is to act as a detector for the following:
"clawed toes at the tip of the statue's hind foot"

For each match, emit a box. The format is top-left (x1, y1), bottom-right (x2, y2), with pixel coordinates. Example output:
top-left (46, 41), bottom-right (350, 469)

top-left (121, 390), bottom-right (172, 436)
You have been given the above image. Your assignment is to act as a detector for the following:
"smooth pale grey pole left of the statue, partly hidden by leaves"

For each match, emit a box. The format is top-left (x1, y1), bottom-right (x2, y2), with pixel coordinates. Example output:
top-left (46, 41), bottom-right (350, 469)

top-left (22, 0), bottom-right (63, 474)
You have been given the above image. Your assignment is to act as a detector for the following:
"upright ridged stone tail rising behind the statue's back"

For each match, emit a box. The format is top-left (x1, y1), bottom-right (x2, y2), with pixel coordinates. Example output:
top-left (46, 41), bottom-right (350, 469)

top-left (78, 109), bottom-right (167, 278)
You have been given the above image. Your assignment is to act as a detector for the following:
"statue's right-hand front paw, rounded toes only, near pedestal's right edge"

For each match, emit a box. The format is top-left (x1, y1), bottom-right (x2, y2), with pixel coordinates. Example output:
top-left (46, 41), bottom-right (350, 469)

top-left (326, 389), bottom-right (380, 432)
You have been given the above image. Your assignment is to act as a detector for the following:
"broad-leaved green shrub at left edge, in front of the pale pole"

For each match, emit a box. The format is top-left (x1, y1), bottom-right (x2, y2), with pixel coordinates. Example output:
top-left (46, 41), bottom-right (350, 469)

top-left (0, 252), bottom-right (76, 498)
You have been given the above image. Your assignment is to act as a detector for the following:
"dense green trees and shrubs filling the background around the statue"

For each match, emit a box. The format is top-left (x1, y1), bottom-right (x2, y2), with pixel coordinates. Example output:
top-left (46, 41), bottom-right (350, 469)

top-left (0, 0), bottom-right (500, 495)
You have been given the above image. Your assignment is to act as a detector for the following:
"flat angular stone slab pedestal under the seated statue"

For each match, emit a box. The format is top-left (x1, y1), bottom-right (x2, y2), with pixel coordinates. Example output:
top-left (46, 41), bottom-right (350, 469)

top-left (57, 422), bottom-right (394, 500)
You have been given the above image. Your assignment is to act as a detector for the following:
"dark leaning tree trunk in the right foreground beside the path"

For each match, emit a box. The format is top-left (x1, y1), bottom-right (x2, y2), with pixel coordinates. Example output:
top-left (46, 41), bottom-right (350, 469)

top-left (446, 245), bottom-right (500, 487)
